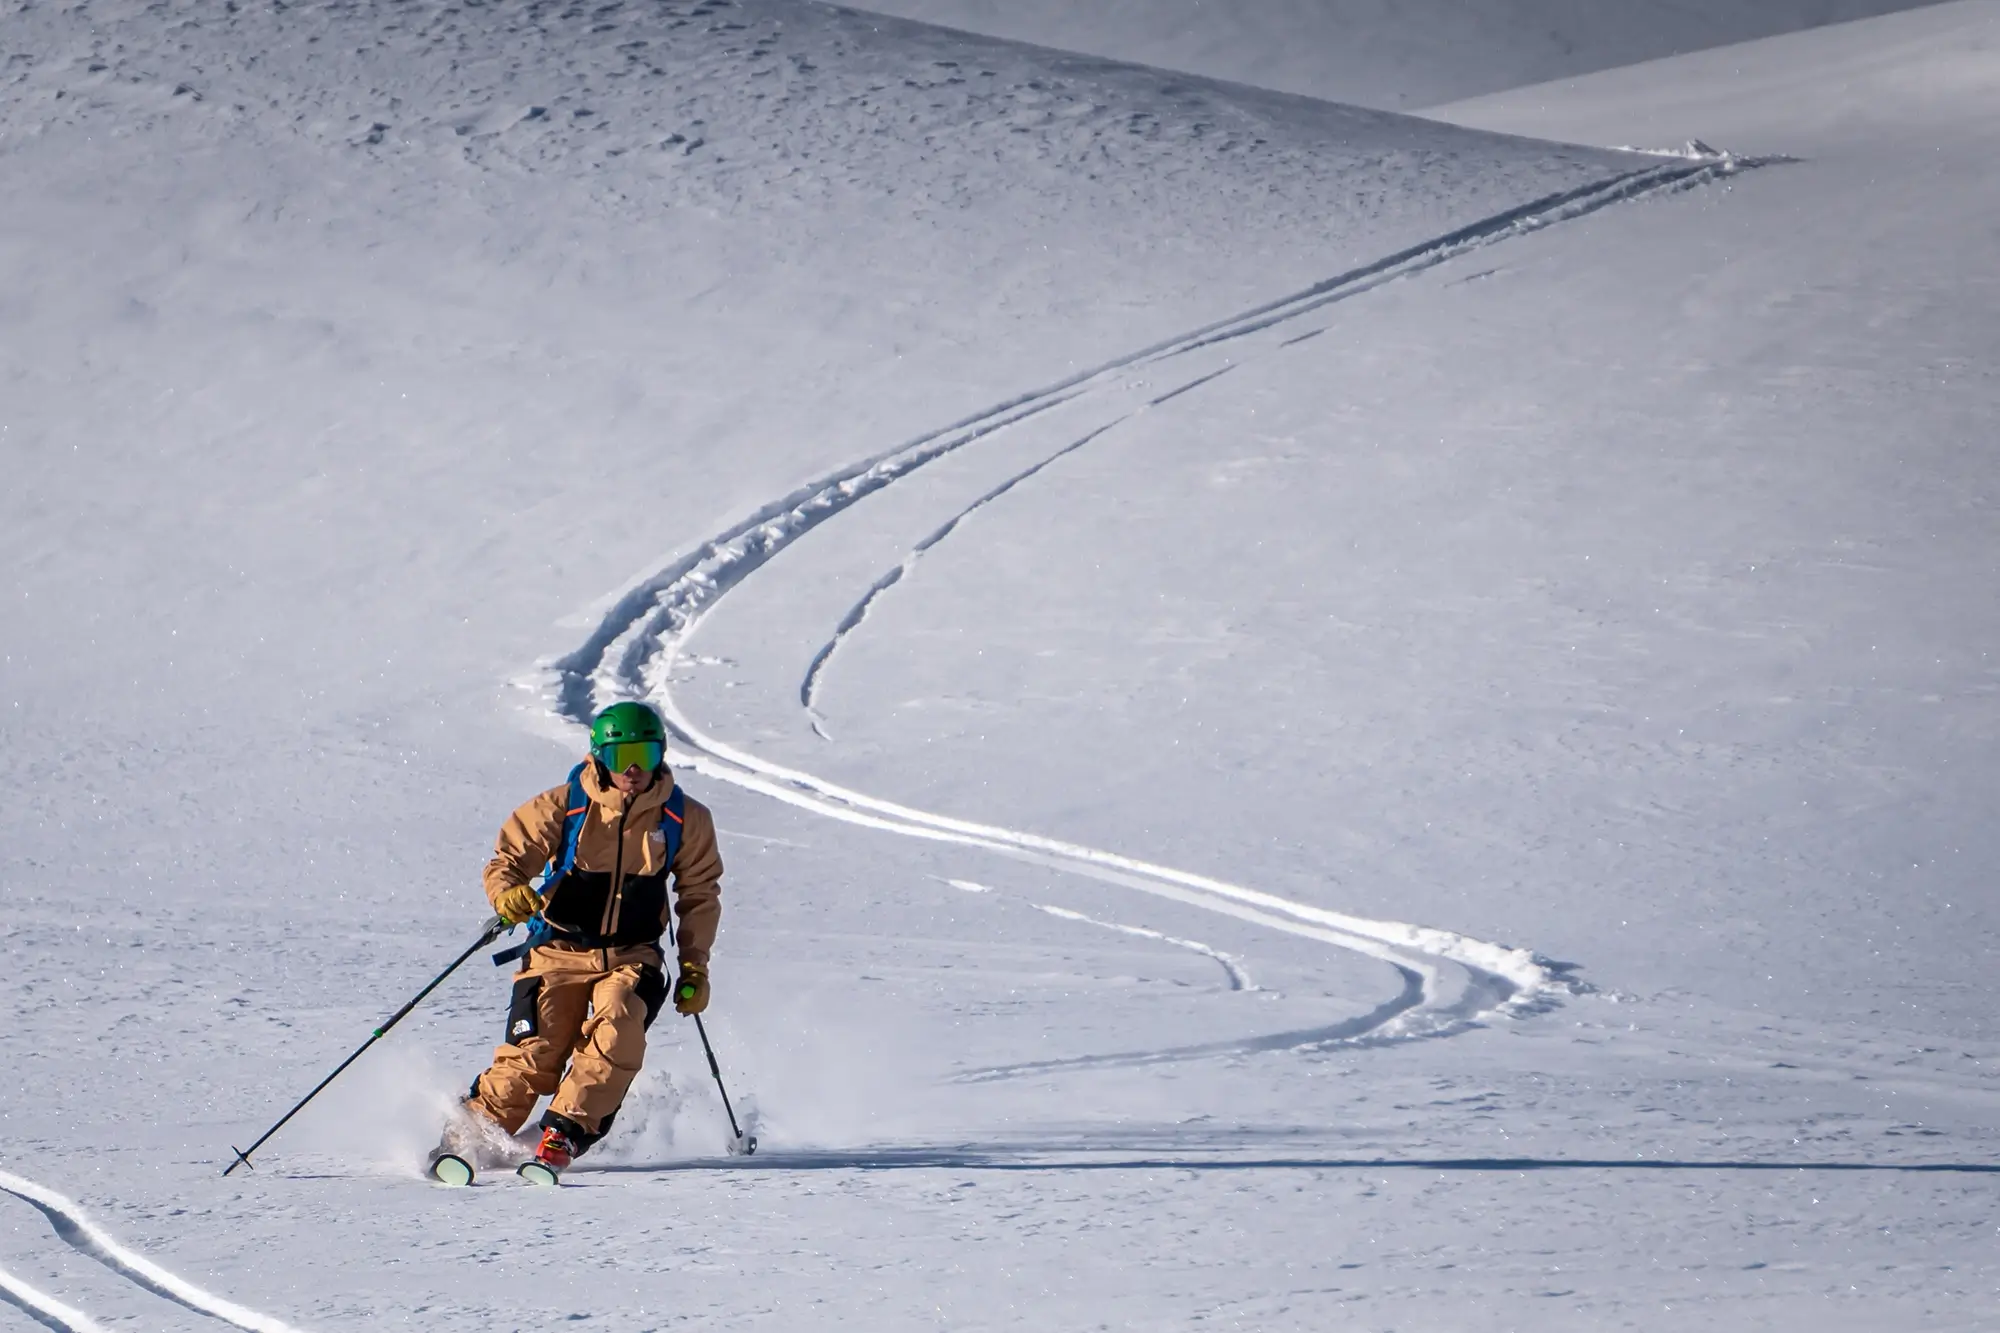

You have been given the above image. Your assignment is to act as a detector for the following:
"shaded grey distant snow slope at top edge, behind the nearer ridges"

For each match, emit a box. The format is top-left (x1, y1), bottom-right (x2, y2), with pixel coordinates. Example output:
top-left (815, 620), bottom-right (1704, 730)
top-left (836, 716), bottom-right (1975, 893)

top-left (836, 0), bottom-right (1944, 110)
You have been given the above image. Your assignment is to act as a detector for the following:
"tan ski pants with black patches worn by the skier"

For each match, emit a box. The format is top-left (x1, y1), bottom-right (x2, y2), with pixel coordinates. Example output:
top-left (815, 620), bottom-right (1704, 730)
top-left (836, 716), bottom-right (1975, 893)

top-left (472, 945), bottom-right (668, 1139)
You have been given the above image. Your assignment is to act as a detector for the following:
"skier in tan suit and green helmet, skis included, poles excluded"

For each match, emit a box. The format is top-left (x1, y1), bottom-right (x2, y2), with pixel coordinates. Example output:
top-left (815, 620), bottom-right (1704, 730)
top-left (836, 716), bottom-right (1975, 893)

top-left (430, 703), bottom-right (722, 1183)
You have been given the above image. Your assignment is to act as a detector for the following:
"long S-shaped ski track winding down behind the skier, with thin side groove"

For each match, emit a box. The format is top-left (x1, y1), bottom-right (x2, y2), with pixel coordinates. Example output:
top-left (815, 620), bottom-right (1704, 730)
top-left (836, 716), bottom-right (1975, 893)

top-left (540, 156), bottom-right (1760, 1079)
